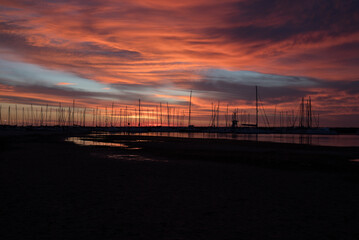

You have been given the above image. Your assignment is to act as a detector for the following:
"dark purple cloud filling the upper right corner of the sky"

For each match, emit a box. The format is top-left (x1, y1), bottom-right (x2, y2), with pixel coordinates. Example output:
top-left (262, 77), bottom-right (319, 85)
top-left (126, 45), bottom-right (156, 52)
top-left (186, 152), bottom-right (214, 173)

top-left (204, 0), bottom-right (359, 43)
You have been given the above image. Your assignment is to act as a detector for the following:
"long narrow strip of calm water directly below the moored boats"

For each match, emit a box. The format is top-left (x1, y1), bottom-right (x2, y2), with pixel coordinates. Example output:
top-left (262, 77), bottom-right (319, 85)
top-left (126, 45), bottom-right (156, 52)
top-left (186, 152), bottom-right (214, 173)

top-left (114, 132), bottom-right (359, 147)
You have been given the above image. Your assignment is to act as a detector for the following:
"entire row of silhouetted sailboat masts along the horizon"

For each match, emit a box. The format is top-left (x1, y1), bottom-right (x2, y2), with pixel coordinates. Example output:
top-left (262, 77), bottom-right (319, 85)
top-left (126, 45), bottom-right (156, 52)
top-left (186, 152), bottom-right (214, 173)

top-left (0, 87), bottom-right (319, 128)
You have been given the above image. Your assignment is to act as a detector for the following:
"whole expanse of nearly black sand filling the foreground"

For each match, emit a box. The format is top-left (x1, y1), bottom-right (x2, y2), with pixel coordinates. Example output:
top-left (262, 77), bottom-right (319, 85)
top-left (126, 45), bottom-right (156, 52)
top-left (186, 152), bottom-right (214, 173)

top-left (0, 130), bottom-right (359, 240)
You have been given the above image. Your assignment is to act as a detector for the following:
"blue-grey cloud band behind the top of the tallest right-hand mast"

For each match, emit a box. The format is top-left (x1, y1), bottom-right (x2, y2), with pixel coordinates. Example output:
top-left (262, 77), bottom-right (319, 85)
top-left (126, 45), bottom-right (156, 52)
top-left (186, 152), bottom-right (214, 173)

top-left (176, 69), bottom-right (359, 104)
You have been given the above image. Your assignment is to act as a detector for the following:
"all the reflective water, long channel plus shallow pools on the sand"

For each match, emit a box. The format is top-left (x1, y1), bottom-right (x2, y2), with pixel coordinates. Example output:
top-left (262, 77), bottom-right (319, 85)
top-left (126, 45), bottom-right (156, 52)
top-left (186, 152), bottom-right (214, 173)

top-left (66, 132), bottom-right (359, 164)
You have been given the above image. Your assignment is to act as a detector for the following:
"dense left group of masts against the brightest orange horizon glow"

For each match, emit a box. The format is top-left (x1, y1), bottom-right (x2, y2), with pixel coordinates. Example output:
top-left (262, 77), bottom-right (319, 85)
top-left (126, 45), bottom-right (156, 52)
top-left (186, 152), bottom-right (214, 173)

top-left (0, 100), bottom-right (190, 127)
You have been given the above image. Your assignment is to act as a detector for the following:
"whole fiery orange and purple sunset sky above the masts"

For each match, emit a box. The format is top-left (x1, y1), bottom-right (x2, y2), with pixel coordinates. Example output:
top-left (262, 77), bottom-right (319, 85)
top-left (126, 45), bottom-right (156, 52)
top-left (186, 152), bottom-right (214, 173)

top-left (0, 0), bottom-right (359, 127)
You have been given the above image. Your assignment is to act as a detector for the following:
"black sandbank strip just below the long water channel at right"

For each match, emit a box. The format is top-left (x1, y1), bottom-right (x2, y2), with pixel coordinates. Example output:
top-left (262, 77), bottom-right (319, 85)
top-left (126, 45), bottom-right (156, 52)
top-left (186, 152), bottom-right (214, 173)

top-left (71, 130), bottom-right (359, 171)
